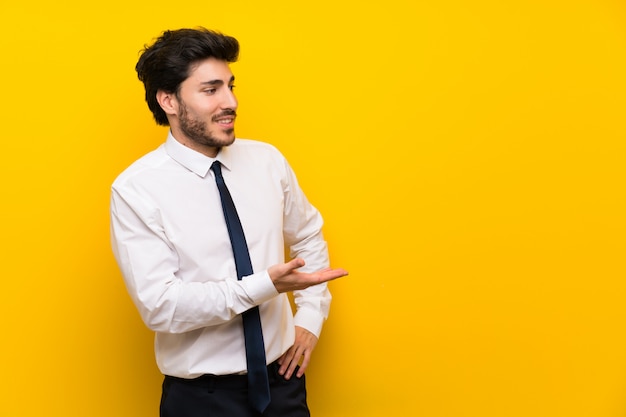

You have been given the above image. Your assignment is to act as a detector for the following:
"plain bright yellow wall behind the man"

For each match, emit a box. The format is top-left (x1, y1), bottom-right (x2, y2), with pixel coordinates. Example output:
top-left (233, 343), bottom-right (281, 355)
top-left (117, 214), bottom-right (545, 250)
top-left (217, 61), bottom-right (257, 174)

top-left (0, 0), bottom-right (626, 417)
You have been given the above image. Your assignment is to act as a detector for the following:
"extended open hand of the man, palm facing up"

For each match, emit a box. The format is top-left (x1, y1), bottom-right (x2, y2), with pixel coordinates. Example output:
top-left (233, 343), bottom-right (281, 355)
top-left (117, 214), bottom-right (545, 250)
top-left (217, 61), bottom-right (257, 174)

top-left (267, 258), bottom-right (348, 292)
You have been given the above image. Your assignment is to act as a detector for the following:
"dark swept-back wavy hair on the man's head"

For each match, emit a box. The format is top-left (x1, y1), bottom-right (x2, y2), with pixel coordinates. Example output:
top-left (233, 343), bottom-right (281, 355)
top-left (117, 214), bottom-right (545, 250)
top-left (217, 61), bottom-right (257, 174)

top-left (135, 27), bottom-right (239, 126)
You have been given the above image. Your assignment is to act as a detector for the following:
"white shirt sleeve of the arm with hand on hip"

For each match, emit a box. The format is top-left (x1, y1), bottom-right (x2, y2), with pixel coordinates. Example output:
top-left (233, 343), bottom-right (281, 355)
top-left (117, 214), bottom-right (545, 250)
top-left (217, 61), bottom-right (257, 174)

top-left (283, 161), bottom-right (332, 338)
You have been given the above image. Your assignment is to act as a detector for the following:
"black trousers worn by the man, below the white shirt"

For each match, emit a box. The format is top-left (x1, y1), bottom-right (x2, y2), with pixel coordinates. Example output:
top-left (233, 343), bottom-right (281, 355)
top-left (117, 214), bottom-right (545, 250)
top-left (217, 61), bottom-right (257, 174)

top-left (161, 362), bottom-right (311, 417)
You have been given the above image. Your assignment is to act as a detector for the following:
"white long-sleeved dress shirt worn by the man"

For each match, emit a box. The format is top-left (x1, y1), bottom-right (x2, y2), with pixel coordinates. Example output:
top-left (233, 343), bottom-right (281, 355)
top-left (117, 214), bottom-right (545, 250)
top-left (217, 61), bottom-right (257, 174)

top-left (111, 133), bottom-right (331, 378)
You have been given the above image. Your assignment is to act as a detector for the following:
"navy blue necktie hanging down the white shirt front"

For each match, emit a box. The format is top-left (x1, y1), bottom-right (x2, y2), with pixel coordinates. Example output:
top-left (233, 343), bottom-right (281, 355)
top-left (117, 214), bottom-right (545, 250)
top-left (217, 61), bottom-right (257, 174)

top-left (211, 161), bottom-right (270, 413)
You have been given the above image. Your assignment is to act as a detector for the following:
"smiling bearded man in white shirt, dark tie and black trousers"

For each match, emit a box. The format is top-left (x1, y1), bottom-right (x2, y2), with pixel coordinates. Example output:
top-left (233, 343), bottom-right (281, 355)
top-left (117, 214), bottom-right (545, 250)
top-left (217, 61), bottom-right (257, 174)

top-left (111, 28), bottom-right (347, 417)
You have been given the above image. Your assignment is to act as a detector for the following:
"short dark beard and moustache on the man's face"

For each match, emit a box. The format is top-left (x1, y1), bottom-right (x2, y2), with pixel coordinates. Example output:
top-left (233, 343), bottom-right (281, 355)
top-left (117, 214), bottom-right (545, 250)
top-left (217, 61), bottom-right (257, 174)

top-left (178, 102), bottom-right (237, 148)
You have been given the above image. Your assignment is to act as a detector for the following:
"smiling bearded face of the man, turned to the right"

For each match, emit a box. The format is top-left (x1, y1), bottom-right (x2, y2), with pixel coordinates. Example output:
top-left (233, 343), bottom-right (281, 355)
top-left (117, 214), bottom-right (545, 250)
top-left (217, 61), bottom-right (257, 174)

top-left (170, 58), bottom-right (237, 157)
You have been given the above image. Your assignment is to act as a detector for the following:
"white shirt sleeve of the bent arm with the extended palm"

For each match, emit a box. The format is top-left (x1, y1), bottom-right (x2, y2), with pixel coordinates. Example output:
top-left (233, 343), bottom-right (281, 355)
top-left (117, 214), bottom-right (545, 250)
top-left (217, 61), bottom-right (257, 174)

top-left (111, 186), bottom-right (278, 333)
